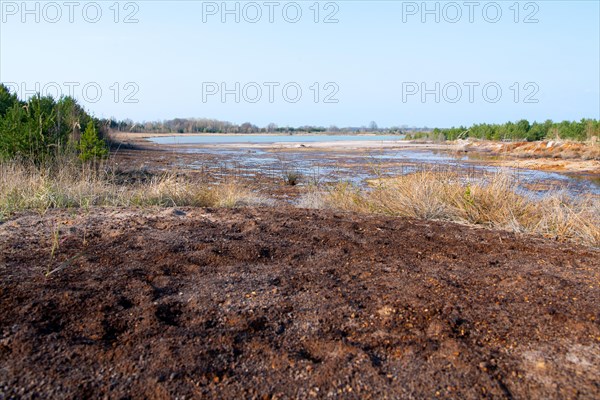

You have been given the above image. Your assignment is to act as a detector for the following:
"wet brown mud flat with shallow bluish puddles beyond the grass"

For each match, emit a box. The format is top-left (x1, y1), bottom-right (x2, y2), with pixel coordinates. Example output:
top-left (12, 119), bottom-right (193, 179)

top-left (116, 142), bottom-right (600, 198)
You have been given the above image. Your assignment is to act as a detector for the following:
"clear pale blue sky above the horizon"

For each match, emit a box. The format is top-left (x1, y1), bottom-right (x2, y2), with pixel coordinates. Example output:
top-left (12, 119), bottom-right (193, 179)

top-left (0, 0), bottom-right (600, 126)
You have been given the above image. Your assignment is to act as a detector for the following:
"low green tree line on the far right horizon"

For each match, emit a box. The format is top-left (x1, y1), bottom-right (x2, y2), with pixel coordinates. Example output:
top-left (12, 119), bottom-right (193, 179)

top-left (424, 119), bottom-right (600, 141)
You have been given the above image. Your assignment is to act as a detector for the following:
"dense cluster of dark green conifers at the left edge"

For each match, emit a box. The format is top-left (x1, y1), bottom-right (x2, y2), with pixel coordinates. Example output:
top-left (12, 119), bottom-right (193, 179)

top-left (0, 84), bottom-right (108, 163)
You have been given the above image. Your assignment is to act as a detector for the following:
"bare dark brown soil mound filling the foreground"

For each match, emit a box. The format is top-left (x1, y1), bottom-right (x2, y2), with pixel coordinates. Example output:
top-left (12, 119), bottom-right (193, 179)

top-left (0, 209), bottom-right (600, 399)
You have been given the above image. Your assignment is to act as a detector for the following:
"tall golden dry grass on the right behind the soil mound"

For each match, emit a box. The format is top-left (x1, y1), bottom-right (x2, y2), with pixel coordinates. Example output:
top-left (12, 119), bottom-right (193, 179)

top-left (310, 171), bottom-right (600, 247)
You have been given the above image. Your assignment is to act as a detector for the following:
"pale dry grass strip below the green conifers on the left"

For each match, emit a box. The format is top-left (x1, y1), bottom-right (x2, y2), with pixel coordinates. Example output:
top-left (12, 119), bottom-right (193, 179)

top-left (0, 162), bottom-right (268, 218)
